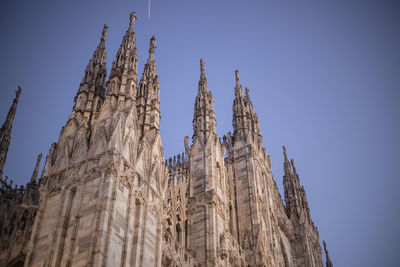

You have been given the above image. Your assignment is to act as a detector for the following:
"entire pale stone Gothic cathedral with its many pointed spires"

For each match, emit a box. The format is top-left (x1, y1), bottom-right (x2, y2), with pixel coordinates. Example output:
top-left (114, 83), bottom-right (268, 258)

top-left (0, 13), bottom-right (332, 267)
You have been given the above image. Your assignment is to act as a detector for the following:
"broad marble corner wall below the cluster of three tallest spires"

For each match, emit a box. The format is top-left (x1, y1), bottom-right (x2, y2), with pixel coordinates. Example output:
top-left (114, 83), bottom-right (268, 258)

top-left (28, 151), bottom-right (162, 266)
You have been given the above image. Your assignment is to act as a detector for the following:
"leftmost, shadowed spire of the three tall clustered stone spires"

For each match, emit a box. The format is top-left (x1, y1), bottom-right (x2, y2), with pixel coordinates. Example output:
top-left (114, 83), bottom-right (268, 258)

top-left (73, 25), bottom-right (108, 121)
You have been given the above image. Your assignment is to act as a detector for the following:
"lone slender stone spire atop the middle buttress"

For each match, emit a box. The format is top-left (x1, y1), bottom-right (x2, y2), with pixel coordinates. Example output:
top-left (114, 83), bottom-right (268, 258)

top-left (193, 59), bottom-right (217, 142)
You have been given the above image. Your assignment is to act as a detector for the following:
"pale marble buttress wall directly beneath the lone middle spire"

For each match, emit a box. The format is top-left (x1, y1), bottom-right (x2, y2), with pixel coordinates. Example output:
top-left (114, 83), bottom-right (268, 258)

top-left (188, 137), bottom-right (228, 266)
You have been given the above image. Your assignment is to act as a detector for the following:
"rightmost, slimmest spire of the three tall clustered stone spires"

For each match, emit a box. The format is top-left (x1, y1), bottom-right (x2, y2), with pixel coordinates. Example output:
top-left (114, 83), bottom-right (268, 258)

top-left (136, 36), bottom-right (161, 134)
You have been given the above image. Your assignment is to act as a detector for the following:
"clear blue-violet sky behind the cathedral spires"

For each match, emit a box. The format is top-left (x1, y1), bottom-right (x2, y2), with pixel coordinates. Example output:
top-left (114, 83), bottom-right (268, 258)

top-left (0, 0), bottom-right (400, 267)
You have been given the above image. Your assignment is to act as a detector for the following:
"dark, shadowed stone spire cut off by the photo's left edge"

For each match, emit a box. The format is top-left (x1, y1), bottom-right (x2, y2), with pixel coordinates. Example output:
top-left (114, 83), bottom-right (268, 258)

top-left (0, 86), bottom-right (22, 178)
